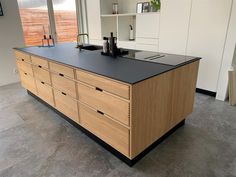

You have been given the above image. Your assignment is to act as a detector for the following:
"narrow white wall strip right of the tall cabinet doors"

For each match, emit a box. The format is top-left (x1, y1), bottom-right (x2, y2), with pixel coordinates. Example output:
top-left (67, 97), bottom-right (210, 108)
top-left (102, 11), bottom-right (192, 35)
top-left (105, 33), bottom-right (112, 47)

top-left (216, 0), bottom-right (236, 101)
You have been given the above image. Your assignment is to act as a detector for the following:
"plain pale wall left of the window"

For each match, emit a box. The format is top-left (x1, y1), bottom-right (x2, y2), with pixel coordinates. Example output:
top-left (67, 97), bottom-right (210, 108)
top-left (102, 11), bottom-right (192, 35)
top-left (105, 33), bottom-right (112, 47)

top-left (0, 0), bottom-right (24, 86)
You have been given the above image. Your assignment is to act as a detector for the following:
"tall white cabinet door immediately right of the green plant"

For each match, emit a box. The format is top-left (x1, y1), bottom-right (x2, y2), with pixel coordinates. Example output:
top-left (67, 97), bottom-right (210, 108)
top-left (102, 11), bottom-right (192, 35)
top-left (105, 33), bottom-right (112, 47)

top-left (159, 0), bottom-right (191, 55)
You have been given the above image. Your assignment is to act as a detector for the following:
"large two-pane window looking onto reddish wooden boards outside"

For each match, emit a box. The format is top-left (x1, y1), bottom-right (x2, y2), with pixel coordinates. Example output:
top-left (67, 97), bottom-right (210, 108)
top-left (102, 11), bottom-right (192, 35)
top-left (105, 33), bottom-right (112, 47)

top-left (18, 0), bottom-right (78, 46)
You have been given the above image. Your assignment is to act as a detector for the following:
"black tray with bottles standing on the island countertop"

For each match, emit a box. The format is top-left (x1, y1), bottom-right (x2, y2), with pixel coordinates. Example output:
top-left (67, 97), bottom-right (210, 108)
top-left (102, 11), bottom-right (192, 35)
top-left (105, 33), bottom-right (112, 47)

top-left (101, 32), bottom-right (128, 57)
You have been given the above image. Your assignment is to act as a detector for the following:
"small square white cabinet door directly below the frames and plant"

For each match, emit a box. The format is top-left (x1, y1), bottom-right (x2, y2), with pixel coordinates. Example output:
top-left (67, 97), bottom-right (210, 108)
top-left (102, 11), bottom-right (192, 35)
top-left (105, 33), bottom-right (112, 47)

top-left (136, 13), bottom-right (160, 39)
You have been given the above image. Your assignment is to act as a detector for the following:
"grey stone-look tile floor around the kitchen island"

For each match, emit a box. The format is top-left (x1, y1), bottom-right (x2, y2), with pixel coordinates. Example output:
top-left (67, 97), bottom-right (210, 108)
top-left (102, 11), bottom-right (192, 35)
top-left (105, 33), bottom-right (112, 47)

top-left (0, 84), bottom-right (236, 177)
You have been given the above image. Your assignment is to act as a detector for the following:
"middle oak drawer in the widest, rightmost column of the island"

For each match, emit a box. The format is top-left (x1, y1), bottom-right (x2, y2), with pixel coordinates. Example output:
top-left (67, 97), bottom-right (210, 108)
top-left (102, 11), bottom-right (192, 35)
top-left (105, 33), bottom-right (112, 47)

top-left (78, 83), bottom-right (130, 125)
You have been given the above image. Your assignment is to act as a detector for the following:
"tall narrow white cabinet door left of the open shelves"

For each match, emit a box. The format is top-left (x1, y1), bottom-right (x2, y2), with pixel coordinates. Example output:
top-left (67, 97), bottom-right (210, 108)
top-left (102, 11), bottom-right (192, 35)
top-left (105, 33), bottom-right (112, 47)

top-left (86, 0), bottom-right (101, 42)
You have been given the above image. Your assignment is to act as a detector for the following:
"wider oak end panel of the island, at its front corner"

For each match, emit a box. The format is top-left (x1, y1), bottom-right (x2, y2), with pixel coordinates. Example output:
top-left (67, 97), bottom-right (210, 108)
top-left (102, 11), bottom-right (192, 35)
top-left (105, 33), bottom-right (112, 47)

top-left (131, 72), bottom-right (173, 158)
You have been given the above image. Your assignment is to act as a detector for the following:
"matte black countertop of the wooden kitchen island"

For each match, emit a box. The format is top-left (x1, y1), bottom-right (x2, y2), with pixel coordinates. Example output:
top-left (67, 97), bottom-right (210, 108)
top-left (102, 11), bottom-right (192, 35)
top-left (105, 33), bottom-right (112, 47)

top-left (15, 43), bottom-right (200, 84)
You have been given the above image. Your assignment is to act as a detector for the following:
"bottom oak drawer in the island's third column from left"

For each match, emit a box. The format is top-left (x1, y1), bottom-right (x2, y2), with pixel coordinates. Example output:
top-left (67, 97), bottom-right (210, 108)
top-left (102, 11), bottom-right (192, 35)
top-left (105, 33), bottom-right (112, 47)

top-left (54, 90), bottom-right (79, 123)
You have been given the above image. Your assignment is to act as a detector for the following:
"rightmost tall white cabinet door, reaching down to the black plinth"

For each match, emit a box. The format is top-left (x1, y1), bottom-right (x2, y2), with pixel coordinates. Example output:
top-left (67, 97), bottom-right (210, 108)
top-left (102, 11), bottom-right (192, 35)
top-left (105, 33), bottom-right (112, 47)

top-left (187, 0), bottom-right (232, 92)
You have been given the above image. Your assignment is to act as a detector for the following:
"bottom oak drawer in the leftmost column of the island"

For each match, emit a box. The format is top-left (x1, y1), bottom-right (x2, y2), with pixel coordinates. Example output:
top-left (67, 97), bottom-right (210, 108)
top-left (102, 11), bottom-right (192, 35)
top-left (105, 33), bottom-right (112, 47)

top-left (19, 70), bottom-right (37, 95)
